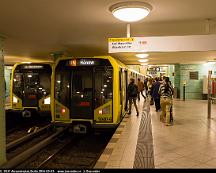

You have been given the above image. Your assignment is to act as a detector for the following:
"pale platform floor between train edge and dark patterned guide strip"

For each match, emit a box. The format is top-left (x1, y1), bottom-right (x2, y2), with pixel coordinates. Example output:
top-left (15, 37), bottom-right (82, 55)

top-left (95, 99), bottom-right (144, 168)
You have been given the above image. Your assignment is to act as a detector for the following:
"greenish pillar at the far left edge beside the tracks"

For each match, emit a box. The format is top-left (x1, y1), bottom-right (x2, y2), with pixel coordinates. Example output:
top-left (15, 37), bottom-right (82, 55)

top-left (0, 36), bottom-right (6, 166)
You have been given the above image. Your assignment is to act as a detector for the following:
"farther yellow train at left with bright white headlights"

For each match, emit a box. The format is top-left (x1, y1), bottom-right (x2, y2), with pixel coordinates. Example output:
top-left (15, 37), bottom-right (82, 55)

top-left (10, 63), bottom-right (53, 117)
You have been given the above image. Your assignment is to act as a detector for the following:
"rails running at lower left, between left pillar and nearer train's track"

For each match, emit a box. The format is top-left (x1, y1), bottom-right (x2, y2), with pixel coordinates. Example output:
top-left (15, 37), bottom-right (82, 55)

top-left (2, 124), bottom-right (67, 169)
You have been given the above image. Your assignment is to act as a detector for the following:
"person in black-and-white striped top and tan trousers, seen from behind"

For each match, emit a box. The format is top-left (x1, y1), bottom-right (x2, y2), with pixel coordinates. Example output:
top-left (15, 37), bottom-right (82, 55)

top-left (159, 77), bottom-right (173, 126)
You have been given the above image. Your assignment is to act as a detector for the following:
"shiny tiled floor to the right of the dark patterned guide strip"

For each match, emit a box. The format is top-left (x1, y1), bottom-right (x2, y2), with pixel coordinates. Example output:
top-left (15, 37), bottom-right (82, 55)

top-left (151, 100), bottom-right (216, 168)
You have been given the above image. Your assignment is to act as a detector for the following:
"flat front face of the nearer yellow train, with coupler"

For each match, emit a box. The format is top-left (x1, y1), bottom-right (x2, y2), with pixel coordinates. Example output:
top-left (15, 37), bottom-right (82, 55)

top-left (53, 58), bottom-right (113, 133)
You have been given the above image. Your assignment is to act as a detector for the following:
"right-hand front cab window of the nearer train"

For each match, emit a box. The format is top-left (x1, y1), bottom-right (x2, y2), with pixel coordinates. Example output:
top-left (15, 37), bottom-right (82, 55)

top-left (94, 66), bottom-right (113, 108)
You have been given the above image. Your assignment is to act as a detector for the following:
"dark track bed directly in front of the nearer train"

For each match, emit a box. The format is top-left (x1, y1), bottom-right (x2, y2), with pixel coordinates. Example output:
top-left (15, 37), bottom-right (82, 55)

top-left (18, 134), bottom-right (112, 169)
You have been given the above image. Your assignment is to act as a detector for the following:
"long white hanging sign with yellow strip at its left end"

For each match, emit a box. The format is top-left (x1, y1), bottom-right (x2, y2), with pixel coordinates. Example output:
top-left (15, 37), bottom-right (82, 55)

top-left (108, 34), bottom-right (216, 53)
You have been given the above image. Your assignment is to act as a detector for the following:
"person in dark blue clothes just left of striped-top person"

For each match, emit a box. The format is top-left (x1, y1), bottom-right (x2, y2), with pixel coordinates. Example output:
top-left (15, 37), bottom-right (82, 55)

top-left (152, 77), bottom-right (161, 112)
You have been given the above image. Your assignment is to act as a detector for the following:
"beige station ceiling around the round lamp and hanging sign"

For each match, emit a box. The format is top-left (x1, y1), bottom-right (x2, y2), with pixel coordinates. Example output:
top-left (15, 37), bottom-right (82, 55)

top-left (0, 0), bottom-right (216, 64)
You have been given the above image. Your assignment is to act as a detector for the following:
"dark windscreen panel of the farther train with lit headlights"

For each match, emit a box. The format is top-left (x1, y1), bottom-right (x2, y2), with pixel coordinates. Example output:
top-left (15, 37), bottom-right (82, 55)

top-left (13, 64), bottom-right (52, 107)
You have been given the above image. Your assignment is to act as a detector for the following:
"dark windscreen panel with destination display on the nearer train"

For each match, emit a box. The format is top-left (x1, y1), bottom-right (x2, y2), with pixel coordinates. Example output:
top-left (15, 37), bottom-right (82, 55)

top-left (55, 59), bottom-right (113, 119)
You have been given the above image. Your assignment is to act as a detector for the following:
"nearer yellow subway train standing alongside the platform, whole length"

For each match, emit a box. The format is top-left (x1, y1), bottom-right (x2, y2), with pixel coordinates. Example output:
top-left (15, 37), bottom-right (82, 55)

top-left (51, 56), bottom-right (144, 133)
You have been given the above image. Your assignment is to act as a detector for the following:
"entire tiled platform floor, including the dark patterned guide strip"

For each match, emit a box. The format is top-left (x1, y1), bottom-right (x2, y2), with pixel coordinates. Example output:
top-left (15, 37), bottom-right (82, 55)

top-left (95, 100), bottom-right (216, 169)
